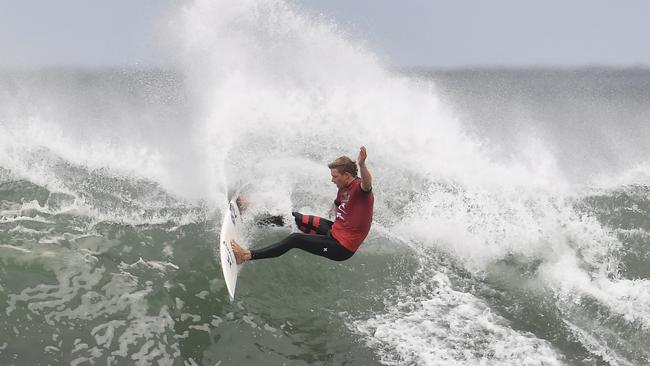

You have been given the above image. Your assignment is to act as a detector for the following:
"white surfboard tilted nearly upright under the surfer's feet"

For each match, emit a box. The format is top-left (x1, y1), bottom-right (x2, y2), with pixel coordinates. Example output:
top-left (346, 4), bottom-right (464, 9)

top-left (219, 196), bottom-right (243, 301)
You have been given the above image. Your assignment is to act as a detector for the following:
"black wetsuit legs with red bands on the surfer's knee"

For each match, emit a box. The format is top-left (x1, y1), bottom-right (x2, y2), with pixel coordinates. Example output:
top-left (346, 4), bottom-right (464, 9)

top-left (251, 212), bottom-right (354, 261)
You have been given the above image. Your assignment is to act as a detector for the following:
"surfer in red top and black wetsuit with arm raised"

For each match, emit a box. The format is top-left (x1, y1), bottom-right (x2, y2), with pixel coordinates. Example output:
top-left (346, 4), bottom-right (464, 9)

top-left (231, 146), bottom-right (374, 264)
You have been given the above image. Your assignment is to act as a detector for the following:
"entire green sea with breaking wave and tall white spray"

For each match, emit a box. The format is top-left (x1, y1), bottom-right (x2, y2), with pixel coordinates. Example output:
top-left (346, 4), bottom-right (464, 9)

top-left (0, 0), bottom-right (650, 365)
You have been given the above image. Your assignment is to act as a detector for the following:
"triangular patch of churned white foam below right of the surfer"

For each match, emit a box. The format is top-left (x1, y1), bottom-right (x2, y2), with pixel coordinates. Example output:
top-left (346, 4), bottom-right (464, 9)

top-left (353, 273), bottom-right (563, 365)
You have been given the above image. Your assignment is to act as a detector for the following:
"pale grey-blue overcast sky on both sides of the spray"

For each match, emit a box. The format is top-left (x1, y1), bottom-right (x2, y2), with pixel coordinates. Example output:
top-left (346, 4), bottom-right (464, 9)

top-left (0, 0), bottom-right (650, 67)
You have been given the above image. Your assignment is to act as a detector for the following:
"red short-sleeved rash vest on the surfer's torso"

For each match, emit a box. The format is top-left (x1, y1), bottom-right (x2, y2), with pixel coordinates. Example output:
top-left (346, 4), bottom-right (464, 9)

top-left (332, 177), bottom-right (375, 252)
